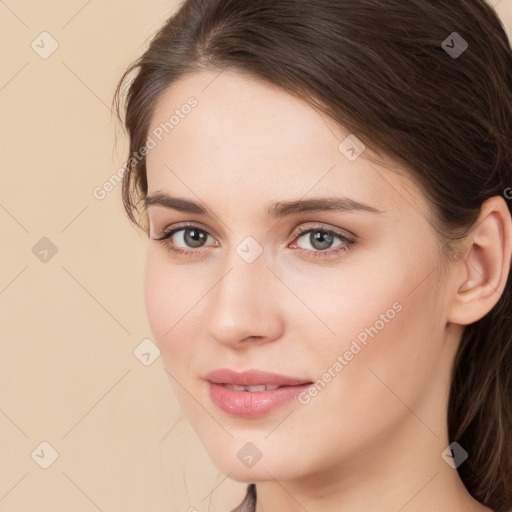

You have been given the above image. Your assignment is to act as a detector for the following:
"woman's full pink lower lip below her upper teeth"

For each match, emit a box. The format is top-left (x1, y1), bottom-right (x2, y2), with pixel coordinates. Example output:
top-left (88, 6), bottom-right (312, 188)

top-left (208, 382), bottom-right (312, 418)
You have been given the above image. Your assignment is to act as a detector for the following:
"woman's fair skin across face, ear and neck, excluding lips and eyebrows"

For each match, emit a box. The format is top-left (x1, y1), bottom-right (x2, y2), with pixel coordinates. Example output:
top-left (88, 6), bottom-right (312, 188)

top-left (145, 71), bottom-right (512, 512)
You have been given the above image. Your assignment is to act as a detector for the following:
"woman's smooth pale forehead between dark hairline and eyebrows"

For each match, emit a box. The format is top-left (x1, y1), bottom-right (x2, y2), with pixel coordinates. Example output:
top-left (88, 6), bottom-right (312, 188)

top-left (147, 70), bottom-right (426, 220)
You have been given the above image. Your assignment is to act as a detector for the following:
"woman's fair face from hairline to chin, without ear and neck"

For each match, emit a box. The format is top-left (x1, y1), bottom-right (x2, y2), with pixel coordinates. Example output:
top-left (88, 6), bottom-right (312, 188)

top-left (145, 71), bottom-right (456, 482)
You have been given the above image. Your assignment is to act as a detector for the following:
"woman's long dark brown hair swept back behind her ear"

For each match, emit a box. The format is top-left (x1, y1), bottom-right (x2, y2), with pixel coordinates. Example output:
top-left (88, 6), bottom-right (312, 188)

top-left (114, 0), bottom-right (512, 512)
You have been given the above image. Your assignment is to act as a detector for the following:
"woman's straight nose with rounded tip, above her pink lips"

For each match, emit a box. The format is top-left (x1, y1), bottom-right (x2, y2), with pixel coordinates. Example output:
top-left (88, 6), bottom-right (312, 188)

top-left (207, 248), bottom-right (284, 348)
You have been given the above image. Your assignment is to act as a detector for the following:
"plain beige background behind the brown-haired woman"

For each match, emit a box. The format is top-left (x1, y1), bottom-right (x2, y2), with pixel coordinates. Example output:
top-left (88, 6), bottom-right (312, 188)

top-left (0, 0), bottom-right (512, 512)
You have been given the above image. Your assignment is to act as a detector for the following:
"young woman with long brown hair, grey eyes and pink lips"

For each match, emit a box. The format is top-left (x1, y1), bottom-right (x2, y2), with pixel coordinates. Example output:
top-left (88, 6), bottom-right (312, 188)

top-left (115, 0), bottom-right (512, 512)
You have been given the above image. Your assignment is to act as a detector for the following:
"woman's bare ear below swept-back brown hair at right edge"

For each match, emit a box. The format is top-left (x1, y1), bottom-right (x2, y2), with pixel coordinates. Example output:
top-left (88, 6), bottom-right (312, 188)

top-left (447, 196), bottom-right (512, 325)
